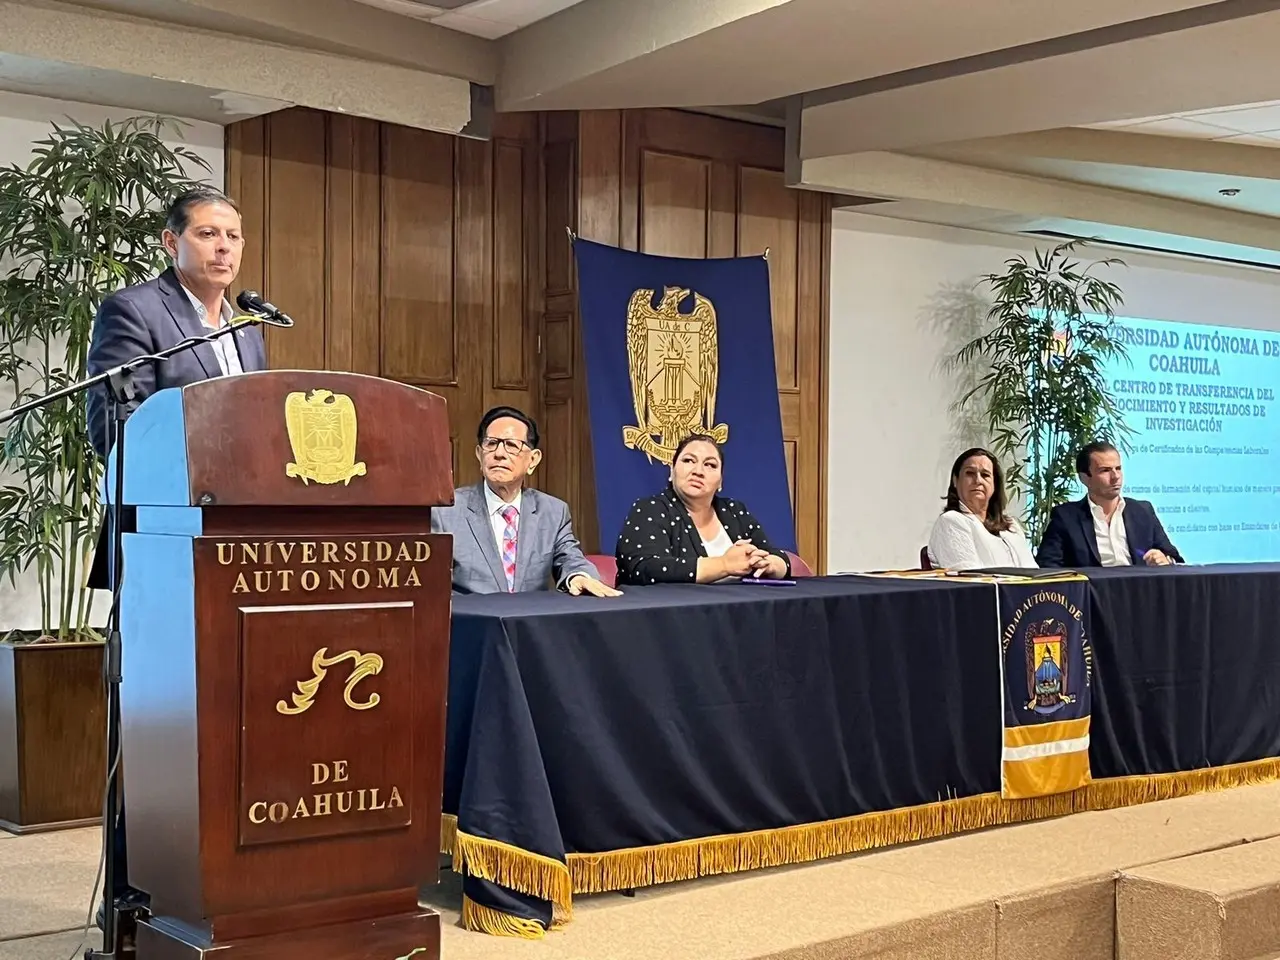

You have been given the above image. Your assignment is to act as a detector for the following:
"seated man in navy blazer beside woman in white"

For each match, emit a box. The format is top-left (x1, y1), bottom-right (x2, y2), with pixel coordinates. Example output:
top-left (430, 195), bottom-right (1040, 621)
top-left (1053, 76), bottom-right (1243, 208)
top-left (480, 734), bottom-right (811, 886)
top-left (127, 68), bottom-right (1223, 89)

top-left (1036, 440), bottom-right (1185, 567)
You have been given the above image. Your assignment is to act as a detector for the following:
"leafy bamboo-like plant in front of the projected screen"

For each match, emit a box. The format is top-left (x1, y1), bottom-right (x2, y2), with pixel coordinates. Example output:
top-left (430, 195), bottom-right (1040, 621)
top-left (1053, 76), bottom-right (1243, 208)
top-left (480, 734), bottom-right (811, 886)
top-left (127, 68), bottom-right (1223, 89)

top-left (951, 241), bottom-right (1132, 543)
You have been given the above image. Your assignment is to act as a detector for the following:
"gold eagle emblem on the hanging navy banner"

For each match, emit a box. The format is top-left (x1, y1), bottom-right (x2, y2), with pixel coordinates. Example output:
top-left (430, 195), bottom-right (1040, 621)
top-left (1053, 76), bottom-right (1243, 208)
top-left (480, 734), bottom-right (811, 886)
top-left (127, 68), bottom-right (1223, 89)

top-left (622, 287), bottom-right (728, 465)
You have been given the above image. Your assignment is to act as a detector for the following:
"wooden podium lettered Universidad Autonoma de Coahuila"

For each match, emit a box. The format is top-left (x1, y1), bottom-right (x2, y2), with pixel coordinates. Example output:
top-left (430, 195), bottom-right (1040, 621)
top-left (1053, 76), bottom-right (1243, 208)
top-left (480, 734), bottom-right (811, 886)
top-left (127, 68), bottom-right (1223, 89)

top-left (120, 370), bottom-right (453, 960)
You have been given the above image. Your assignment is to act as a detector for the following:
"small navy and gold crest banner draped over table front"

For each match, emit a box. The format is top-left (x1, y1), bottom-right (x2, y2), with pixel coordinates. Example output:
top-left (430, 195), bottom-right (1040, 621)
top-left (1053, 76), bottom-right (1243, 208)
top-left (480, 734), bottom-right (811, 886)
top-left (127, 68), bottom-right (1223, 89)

top-left (996, 576), bottom-right (1093, 800)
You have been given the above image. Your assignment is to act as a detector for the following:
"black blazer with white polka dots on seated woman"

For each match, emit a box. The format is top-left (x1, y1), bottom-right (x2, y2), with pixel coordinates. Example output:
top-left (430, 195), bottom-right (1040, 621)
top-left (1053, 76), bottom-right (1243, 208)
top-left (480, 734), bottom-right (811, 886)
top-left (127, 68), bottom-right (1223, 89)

top-left (614, 484), bottom-right (791, 585)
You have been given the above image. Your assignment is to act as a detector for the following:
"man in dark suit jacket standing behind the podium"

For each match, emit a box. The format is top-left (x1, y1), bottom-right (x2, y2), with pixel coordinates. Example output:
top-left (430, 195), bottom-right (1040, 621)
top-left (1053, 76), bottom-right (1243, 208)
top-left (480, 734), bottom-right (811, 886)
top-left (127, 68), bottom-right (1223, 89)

top-left (88, 187), bottom-right (266, 936)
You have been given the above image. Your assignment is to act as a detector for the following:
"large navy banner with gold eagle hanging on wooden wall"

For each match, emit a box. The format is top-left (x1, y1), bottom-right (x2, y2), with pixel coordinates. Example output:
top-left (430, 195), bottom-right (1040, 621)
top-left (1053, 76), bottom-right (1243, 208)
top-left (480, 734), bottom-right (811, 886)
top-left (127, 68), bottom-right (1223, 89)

top-left (573, 239), bottom-right (795, 553)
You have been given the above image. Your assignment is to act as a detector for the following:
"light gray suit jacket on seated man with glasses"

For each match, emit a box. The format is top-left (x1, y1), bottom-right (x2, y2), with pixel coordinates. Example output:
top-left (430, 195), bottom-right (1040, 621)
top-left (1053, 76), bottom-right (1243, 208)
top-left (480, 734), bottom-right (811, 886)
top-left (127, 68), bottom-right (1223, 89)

top-left (431, 480), bottom-right (600, 594)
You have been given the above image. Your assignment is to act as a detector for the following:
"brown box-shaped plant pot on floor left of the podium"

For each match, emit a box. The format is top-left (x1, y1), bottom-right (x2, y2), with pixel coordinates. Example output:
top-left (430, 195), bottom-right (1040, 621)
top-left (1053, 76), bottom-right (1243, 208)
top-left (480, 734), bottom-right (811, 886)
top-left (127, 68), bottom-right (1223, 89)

top-left (0, 641), bottom-right (106, 833)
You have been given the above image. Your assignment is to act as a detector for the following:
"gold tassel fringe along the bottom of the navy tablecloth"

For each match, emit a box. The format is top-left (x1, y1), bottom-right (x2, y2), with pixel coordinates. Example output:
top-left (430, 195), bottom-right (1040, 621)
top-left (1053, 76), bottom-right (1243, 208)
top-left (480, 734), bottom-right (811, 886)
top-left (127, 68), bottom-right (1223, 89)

top-left (440, 758), bottom-right (1280, 916)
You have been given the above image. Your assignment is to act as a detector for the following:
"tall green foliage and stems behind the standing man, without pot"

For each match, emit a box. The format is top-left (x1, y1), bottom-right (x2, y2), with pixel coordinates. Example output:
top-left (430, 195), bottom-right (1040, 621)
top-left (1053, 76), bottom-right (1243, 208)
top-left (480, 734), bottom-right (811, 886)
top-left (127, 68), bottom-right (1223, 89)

top-left (0, 116), bottom-right (210, 640)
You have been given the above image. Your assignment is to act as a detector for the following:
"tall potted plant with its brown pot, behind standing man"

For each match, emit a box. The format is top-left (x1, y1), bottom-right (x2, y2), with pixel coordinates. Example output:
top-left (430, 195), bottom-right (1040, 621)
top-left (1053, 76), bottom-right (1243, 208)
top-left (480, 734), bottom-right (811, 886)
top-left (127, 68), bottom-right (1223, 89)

top-left (0, 116), bottom-right (210, 831)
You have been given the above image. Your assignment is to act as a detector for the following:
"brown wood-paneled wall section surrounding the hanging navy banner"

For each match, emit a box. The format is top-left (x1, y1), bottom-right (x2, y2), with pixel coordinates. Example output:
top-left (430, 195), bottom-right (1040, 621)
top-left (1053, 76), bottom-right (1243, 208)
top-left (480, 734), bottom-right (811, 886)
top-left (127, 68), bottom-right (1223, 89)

top-left (543, 110), bottom-right (831, 570)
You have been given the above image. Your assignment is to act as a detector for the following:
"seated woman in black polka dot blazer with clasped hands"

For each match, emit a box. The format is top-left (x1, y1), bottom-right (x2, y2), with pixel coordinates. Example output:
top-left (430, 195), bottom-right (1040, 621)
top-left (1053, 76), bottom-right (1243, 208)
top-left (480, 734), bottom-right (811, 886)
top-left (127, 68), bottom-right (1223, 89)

top-left (616, 434), bottom-right (791, 585)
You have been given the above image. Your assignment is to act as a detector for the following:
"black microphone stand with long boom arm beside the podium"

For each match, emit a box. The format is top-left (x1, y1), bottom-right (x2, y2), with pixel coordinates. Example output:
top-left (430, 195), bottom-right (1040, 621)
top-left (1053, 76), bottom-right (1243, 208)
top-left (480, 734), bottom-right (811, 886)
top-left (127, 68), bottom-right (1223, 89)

top-left (0, 315), bottom-right (277, 960)
